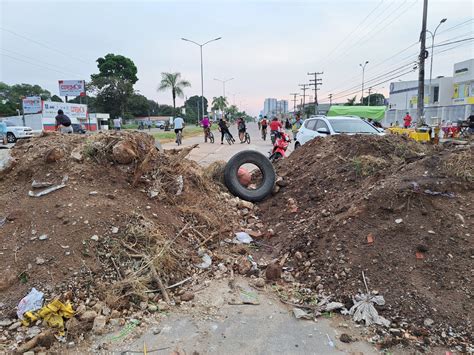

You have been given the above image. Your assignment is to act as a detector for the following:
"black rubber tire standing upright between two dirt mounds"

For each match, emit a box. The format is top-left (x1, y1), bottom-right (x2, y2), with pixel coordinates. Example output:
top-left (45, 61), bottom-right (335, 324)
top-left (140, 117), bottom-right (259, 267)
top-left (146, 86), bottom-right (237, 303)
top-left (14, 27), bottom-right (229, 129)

top-left (224, 150), bottom-right (276, 202)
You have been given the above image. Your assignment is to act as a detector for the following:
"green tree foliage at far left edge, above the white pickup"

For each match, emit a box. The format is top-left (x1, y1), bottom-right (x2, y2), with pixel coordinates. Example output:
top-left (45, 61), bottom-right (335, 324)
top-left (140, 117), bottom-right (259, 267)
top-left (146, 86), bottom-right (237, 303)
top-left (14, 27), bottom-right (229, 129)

top-left (0, 82), bottom-right (51, 116)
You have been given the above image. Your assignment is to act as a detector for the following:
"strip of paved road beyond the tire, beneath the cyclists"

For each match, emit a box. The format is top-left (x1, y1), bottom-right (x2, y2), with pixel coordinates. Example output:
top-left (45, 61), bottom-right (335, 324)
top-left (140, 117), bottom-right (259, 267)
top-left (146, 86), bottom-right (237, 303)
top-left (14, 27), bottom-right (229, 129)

top-left (163, 123), bottom-right (293, 166)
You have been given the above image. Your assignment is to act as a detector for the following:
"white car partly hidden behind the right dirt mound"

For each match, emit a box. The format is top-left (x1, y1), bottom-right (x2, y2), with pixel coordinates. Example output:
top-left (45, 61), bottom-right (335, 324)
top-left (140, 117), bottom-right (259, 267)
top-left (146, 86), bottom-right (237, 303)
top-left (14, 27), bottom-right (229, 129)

top-left (295, 116), bottom-right (384, 149)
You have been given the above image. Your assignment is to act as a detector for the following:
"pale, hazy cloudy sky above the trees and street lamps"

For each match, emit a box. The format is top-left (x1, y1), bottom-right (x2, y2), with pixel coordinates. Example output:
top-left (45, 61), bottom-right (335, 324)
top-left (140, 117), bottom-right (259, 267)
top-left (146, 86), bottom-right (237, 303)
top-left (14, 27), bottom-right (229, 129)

top-left (0, 0), bottom-right (474, 115)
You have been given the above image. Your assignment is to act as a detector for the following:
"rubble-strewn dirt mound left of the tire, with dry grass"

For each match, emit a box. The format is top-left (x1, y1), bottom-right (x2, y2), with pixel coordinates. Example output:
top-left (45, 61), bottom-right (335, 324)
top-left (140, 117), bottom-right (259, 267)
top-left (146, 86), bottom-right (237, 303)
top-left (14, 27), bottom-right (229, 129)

top-left (0, 132), bottom-right (249, 350)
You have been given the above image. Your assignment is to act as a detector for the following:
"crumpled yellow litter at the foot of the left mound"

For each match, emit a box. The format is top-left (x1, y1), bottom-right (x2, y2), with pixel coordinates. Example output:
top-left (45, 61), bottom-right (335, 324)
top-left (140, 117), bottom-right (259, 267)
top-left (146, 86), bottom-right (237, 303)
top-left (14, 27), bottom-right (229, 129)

top-left (22, 299), bottom-right (74, 335)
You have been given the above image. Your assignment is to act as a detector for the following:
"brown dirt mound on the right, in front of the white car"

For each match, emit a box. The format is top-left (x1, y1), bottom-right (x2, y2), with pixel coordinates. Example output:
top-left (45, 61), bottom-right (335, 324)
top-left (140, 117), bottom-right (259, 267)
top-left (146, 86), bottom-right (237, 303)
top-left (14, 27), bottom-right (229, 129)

top-left (259, 135), bottom-right (474, 351)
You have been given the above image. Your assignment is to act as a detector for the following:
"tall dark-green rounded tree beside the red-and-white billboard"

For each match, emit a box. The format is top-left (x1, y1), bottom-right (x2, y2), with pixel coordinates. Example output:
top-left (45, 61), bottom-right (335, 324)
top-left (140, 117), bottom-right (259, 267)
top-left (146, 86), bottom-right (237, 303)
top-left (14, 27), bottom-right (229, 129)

top-left (90, 53), bottom-right (138, 117)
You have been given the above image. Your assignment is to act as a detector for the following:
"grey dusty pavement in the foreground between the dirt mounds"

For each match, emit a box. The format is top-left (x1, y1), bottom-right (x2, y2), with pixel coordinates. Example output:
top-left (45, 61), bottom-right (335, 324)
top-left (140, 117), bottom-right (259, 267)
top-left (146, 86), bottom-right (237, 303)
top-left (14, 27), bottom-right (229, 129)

top-left (102, 278), bottom-right (377, 354)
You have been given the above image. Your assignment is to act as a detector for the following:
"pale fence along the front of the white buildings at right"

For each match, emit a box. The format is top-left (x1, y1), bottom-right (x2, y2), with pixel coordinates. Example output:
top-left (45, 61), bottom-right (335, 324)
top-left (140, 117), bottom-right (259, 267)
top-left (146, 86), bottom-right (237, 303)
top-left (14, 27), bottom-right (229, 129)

top-left (381, 105), bottom-right (474, 127)
